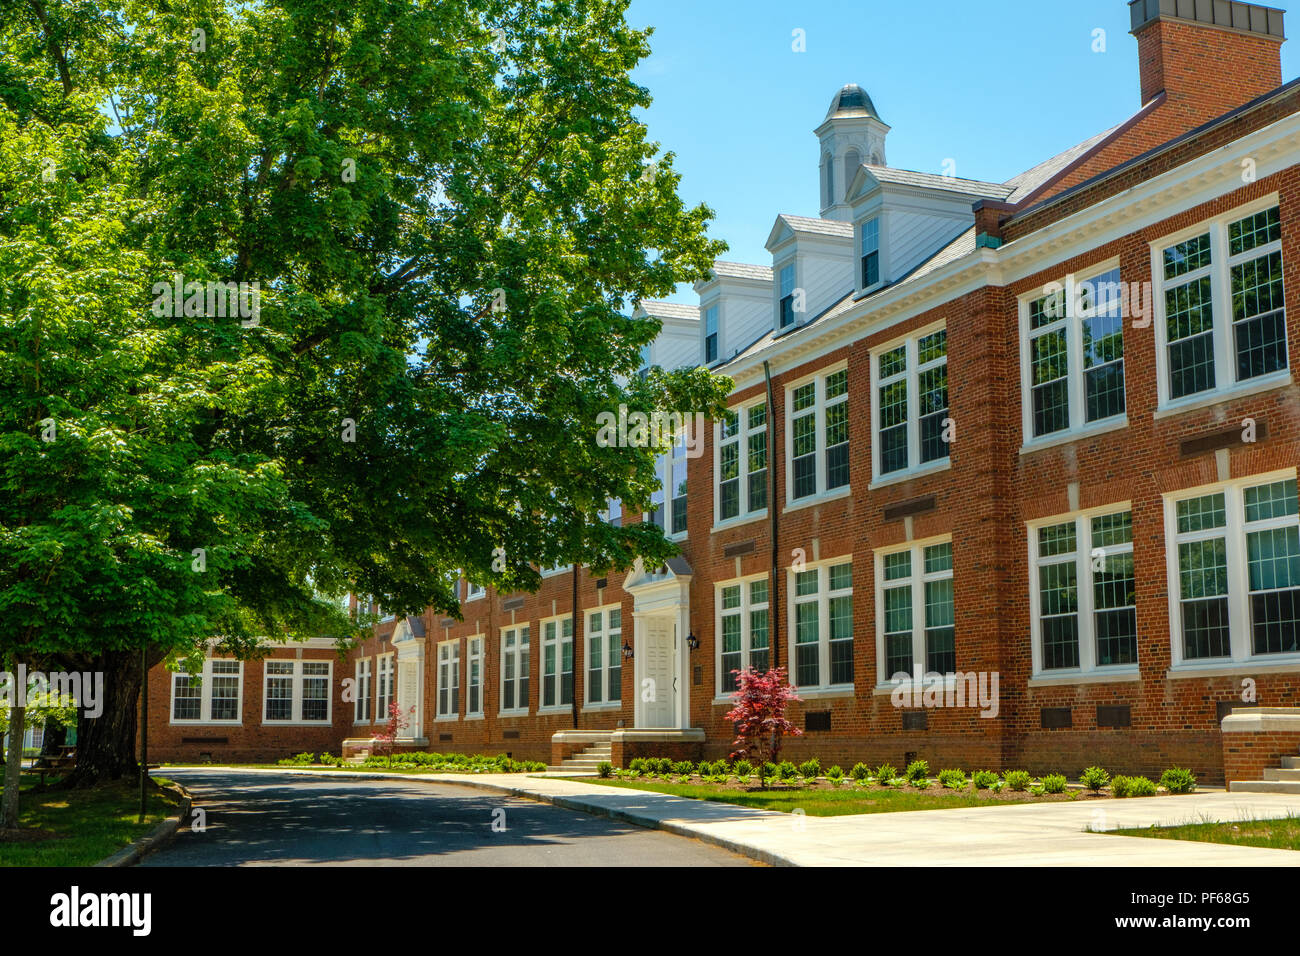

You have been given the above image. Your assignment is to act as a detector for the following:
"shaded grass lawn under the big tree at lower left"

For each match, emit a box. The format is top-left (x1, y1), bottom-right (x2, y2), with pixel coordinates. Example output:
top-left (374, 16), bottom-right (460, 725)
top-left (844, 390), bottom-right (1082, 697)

top-left (0, 778), bottom-right (176, 866)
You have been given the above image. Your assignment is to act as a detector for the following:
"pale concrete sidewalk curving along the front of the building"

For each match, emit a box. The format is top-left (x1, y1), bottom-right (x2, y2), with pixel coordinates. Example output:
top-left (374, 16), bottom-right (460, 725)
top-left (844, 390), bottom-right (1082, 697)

top-left (163, 769), bottom-right (1300, 866)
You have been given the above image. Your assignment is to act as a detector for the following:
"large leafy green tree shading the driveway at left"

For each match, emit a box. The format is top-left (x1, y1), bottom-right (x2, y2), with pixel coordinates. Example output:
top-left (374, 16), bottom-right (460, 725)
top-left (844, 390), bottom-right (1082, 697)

top-left (0, 0), bottom-right (727, 801)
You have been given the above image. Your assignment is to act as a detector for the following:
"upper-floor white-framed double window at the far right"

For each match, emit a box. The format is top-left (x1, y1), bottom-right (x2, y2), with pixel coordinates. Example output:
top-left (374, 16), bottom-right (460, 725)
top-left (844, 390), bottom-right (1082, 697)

top-left (1152, 198), bottom-right (1288, 407)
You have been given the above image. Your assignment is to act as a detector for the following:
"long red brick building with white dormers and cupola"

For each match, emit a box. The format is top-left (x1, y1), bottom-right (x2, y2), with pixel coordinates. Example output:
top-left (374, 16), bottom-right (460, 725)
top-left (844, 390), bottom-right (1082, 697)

top-left (153, 0), bottom-right (1300, 779)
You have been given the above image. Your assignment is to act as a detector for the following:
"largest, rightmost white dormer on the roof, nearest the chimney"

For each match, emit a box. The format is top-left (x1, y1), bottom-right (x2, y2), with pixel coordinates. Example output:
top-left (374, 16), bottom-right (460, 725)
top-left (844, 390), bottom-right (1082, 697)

top-left (848, 164), bottom-right (1011, 293)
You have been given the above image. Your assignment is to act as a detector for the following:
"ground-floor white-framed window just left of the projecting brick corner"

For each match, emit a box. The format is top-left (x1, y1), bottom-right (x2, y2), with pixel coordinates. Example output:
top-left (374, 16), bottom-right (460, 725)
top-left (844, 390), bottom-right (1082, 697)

top-left (876, 538), bottom-right (957, 684)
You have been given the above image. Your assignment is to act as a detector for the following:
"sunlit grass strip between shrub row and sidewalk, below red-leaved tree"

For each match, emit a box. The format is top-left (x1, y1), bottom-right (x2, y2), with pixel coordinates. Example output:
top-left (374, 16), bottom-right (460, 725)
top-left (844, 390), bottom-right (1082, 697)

top-left (579, 777), bottom-right (1050, 817)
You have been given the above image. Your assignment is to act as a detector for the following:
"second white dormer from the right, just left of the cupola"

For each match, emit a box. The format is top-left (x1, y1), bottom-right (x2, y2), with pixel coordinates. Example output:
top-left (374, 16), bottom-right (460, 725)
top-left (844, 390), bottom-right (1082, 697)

top-left (767, 215), bottom-right (857, 333)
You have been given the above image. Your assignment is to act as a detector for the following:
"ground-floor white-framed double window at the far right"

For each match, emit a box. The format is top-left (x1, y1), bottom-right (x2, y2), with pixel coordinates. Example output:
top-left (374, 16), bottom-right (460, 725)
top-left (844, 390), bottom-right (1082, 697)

top-left (1165, 470), bottom-right (1300, 666)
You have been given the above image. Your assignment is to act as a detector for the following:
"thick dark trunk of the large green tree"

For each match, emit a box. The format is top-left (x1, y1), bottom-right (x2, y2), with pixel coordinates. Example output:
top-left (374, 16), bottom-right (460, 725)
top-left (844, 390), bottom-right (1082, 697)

top-left (62, 650), bottom-right (140, 787)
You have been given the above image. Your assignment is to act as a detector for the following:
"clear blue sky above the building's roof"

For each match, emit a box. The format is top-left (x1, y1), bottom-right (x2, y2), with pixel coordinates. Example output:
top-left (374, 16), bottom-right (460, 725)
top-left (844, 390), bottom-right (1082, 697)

top-left (628, 0), bottom-right (1300, 295)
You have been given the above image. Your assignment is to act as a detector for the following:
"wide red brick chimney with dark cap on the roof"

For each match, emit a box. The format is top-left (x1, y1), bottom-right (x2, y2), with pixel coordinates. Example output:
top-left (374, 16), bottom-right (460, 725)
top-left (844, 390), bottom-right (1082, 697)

top-left (1128, 0), bottom-right (1286, 116)
